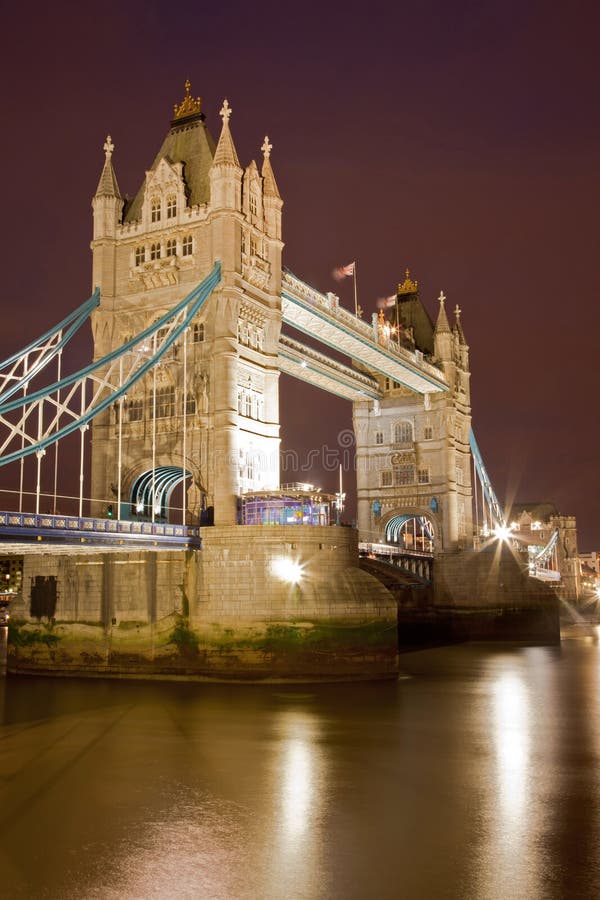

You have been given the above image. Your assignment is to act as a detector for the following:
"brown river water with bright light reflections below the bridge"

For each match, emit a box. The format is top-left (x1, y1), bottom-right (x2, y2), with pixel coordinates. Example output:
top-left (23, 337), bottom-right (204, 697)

top-left (0, 629), bottom-right (600, 900)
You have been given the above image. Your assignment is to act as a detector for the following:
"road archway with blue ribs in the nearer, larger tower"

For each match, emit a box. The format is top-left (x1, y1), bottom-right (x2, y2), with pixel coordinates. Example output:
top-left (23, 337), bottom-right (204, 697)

top-left (129, 466), bottom-right (192, 523)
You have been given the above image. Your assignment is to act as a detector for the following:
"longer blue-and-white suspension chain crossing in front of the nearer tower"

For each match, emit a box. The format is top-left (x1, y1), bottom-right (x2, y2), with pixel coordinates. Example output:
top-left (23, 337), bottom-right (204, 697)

top-left (0, 262), bottom-right (221, 465)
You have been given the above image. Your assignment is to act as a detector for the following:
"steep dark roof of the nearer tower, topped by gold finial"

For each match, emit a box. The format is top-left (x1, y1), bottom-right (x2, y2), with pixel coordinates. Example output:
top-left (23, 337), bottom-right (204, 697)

top-left (124, 80), bottom-right (215, 222)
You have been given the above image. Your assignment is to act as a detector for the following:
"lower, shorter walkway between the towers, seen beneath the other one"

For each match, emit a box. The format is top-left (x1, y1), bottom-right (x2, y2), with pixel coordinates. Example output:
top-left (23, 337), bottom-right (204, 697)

top-left (279, 334), bottom-right (382, 401)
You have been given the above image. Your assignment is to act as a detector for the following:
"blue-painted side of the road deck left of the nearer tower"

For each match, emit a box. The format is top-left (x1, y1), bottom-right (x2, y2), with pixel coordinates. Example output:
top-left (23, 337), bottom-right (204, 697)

top-left (0, 512), bottom-right (201, 550)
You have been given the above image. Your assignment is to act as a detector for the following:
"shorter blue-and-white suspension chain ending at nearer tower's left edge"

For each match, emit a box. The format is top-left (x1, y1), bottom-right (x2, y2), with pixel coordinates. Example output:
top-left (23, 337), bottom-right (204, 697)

top-left (0, 288), bottom-right (100, 403)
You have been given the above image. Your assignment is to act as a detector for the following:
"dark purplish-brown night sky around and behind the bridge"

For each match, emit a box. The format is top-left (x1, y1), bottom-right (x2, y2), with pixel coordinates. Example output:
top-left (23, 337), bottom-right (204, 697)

top-left (0, 0), bottom-right (600, 550)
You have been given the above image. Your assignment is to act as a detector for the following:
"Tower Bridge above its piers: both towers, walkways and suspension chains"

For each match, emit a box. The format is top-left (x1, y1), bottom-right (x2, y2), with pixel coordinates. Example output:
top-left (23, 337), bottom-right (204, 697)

top-left (0, 85), bottom-right (556, 576)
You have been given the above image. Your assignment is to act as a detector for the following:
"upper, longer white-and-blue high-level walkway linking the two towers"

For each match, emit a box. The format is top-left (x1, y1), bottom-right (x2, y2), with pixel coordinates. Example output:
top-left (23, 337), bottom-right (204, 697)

top-left (281, 273), bottom-right (448, 394)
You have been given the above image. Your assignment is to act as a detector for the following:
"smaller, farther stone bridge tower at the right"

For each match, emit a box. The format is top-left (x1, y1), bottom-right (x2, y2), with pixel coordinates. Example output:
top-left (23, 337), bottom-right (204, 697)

top-left (354, 271), bottom-right (473, 552)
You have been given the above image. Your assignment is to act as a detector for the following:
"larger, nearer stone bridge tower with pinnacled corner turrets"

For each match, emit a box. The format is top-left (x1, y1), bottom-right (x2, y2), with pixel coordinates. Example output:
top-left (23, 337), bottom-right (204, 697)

top-left (91, 82), bottom-right (283, 525)
